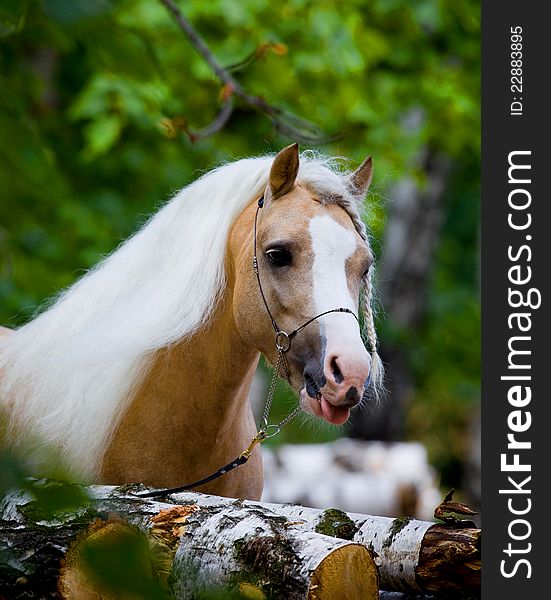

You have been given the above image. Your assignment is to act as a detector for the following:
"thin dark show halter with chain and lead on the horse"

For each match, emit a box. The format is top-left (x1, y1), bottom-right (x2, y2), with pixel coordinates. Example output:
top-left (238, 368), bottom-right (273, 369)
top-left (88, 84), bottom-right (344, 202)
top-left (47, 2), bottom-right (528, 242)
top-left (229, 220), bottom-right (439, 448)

top-left (135, 195), bottom-right (359, 498)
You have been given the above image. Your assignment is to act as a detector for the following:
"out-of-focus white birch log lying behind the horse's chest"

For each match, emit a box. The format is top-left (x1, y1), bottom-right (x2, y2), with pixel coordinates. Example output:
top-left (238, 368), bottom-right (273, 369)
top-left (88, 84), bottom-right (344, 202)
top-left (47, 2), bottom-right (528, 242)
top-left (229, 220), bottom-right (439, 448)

top-left (262, 438), bottom-right (440, 520)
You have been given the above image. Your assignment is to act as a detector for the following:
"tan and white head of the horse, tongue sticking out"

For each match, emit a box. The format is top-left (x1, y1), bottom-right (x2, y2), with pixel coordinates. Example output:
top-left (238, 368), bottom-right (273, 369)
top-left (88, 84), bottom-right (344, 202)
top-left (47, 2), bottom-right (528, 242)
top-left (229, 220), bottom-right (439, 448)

top-left (230, 144), bottom-right (378, 425)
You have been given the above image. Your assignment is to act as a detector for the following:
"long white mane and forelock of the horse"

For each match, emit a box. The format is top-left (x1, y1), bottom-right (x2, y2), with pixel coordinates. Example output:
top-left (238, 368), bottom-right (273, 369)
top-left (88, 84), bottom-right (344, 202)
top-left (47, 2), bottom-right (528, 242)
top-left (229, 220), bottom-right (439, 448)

top-left (0, 153), bottom-right (366, 477)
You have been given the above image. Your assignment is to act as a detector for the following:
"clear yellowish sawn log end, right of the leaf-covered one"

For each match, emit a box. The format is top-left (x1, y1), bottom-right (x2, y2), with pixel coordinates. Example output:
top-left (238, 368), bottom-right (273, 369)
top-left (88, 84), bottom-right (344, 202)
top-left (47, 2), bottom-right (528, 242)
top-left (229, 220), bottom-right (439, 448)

top-left (308, 544), bottom-right (379, 600)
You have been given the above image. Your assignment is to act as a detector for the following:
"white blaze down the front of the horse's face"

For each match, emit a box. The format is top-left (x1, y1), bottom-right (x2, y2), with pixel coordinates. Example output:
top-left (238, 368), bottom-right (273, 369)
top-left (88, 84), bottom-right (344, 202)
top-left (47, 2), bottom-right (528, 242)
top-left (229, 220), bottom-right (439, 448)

top-left (308, 215), bottom-right (364, 354)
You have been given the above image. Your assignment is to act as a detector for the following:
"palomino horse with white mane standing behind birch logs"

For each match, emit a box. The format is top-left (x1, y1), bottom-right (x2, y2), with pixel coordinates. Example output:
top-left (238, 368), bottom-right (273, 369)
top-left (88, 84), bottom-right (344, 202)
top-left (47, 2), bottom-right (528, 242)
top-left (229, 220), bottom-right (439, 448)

top-left (0, 144), bottom-right (381, 499)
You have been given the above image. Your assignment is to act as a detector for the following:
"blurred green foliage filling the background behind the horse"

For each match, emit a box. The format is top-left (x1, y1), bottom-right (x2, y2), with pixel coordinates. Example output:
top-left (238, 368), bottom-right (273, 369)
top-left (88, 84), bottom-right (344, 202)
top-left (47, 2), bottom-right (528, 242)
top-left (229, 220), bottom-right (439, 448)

top-left (0, 0), bottom-right (480, 488)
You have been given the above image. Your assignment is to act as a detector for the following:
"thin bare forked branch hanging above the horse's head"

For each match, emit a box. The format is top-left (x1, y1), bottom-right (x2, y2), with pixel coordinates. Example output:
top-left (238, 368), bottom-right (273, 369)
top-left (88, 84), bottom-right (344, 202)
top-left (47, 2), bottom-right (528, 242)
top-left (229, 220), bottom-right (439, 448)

top-left (160, 0), bottom-right (340, 144)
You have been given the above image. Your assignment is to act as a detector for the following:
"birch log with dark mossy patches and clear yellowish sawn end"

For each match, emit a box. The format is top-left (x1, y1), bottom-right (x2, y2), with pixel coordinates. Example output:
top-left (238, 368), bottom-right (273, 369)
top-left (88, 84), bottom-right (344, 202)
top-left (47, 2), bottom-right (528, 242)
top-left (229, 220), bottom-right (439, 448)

top-left (173, 501), bottom-right (379, 600)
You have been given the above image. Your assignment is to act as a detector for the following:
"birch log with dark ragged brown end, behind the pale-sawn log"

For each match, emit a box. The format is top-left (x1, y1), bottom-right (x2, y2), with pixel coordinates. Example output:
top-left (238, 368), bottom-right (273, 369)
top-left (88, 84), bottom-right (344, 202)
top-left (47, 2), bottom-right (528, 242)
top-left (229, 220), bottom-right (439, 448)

top-left (173, 492), bottom-right (481, 597)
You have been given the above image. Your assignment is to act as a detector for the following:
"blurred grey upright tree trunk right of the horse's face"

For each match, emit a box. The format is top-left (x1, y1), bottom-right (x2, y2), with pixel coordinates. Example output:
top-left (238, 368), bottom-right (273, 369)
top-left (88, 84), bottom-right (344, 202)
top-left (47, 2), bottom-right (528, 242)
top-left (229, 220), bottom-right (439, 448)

top-left (351, 148), bottom-right (449, 441)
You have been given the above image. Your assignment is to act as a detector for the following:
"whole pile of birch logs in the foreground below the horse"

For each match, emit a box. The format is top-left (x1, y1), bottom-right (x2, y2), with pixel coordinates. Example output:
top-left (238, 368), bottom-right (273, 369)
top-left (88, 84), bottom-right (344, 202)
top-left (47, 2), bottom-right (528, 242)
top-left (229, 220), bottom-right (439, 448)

top-left (0, 482), bottom-right (480, 600)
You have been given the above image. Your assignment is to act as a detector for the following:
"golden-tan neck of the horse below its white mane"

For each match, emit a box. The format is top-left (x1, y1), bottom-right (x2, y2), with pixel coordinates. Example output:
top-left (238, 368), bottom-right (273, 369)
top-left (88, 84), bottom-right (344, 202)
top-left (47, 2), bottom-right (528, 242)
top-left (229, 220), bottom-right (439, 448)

top-left (100, 229), bottom-right (261, 488)
